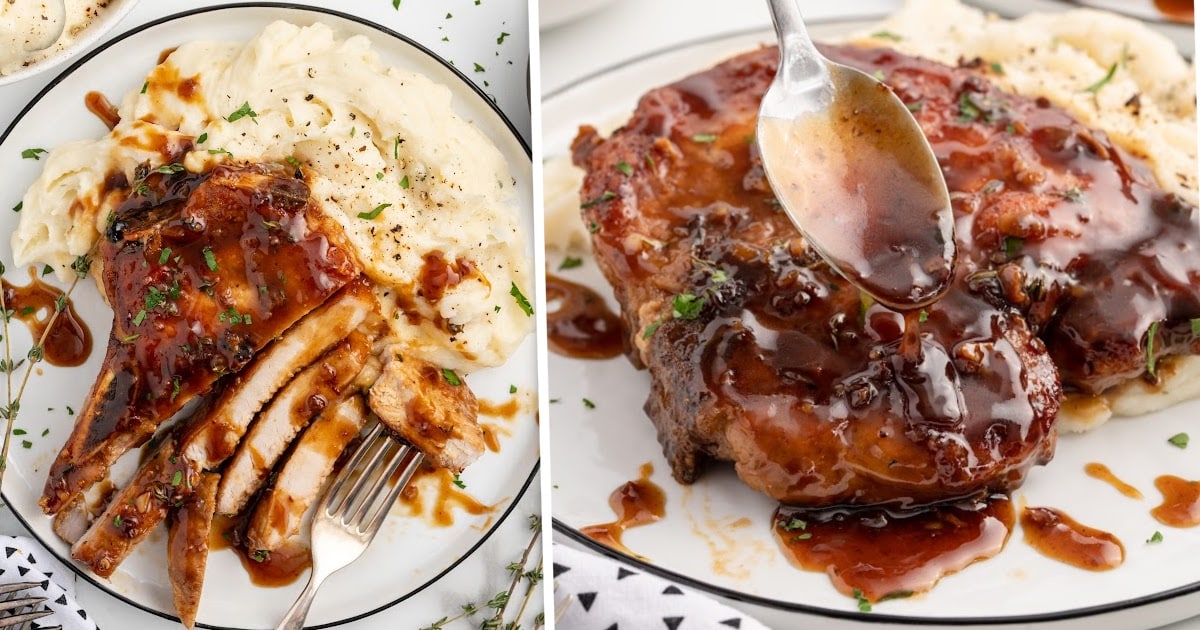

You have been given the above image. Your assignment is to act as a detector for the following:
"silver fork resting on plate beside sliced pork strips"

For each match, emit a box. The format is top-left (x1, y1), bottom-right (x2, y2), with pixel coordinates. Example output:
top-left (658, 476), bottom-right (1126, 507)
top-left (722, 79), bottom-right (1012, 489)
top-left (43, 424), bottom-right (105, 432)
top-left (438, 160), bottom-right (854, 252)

top-left (276, 422), bottom-right (425, 630)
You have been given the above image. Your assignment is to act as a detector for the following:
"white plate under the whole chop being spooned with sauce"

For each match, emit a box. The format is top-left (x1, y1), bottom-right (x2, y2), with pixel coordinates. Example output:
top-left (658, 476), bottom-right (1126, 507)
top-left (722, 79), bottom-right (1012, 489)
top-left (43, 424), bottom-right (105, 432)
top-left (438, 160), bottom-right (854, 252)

top-left (542, 23), bottom-right (1200, 628)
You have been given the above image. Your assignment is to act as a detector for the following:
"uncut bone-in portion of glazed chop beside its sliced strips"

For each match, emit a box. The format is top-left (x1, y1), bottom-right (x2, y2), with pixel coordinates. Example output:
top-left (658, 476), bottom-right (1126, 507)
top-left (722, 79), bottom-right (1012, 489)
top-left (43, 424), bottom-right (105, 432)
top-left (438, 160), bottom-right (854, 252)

top-left (41, 164), bottom-right (358, 514)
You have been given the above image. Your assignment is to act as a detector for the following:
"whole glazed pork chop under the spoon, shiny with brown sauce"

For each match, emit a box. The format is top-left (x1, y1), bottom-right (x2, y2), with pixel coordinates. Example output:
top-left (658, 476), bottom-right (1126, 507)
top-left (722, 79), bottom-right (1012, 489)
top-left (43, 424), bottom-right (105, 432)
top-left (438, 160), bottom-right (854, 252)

top-left (574, 42), bottom-right (1200, 506)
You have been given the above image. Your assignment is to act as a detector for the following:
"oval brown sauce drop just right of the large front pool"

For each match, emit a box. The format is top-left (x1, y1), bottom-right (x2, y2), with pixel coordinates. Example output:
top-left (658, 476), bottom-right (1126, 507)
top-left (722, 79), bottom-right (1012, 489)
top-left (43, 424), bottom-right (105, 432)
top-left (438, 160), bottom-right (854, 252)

top-left (1021, 508), bottom-right (1124, 571)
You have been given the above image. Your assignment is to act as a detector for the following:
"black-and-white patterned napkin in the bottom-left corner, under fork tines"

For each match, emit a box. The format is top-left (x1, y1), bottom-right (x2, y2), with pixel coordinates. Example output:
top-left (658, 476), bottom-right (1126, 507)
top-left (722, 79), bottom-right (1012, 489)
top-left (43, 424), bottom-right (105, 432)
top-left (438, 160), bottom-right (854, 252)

top-left (0, 535), bottom-right (96, 630)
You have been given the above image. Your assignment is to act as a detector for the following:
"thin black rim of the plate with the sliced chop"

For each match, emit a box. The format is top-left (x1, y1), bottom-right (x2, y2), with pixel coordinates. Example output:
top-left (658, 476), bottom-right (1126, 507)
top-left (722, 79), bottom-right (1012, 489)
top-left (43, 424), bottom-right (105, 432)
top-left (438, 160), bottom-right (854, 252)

top-left (0, 2), bottom-right (541, 630)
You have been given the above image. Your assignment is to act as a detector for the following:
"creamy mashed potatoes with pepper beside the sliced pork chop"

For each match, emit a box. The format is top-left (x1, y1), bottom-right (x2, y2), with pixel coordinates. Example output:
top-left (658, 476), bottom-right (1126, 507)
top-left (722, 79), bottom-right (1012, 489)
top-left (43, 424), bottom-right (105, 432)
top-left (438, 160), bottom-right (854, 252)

top-left (13, 23), bottom-right (533, 372)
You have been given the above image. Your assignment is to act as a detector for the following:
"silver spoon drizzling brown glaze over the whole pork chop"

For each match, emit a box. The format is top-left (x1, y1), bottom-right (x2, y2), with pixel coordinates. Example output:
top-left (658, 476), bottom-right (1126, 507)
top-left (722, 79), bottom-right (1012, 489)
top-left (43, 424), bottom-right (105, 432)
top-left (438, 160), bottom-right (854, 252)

top-left (757, 0), bottom-right (956, 311)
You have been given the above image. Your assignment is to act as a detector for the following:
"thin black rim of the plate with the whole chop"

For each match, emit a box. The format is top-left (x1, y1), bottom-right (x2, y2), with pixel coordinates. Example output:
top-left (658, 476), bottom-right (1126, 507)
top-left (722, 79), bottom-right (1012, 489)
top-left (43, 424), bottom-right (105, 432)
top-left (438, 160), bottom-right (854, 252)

top-left (542, 14), bottom-right (1200, 626)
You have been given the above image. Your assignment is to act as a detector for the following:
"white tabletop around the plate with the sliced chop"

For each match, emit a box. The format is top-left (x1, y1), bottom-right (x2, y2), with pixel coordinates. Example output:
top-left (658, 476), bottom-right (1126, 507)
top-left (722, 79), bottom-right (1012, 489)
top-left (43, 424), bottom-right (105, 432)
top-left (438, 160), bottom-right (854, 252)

top-left (0, 0), bottom-right (540, 630)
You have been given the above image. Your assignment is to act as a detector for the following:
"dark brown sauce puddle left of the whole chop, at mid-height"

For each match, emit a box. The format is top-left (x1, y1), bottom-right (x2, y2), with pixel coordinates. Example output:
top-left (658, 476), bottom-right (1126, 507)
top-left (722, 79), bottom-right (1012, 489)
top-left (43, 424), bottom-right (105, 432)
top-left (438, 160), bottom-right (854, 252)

top-left (546, 274), bottom-right (626, 359)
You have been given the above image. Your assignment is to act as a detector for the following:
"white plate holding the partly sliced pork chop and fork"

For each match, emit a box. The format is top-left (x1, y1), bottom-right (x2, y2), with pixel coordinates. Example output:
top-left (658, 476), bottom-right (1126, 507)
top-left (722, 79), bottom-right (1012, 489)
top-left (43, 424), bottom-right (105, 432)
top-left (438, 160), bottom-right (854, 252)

top-left (0, 6), bottom-right (538, 628)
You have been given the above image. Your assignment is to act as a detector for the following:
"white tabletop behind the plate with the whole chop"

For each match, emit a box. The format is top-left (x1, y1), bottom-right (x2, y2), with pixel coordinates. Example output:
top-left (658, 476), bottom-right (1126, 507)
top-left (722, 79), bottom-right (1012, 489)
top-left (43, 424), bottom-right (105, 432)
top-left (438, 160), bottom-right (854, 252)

top-left (539, 0), bottom-right (1200, 630)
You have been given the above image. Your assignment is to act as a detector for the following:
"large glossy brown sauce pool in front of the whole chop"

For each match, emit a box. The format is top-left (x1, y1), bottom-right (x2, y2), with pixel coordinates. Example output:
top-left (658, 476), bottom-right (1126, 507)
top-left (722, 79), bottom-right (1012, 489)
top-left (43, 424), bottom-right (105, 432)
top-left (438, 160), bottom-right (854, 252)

top-left (773, 496), bottom-right (1014, 601)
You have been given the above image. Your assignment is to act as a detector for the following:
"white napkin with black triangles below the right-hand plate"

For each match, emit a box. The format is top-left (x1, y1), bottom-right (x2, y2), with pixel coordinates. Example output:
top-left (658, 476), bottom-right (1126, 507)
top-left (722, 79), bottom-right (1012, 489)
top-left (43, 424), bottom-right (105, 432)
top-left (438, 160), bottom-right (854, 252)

top-left (554, 545), bottom-right (767, 630)
